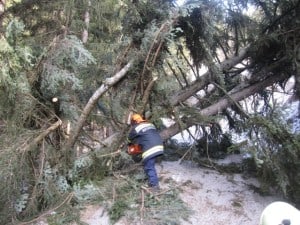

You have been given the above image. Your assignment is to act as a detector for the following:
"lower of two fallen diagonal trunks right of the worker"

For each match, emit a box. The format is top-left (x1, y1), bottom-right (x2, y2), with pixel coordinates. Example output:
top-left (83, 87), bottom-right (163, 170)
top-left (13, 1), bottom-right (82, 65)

top-left (160, 71), bottom-right (287, 140)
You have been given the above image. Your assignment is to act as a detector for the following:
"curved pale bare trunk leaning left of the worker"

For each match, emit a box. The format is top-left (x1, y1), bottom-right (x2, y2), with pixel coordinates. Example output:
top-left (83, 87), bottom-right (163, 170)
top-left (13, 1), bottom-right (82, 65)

top-left (65, 60), bottom-right (133, 150)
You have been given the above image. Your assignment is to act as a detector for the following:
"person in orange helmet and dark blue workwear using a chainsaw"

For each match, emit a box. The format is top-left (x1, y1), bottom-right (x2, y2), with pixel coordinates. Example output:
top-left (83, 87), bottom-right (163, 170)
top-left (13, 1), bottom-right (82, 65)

top-left (128, 113), bottom-right (164, 192)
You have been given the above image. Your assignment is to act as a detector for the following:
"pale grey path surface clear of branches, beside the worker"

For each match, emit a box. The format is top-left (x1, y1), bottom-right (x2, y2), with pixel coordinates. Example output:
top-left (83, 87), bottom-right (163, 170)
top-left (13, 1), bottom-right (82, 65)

top-left (82, 162), bottom-right (281, 225)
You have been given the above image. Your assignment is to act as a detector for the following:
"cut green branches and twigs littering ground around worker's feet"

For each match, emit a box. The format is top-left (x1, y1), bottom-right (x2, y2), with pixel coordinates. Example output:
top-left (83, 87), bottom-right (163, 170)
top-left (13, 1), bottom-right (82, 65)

top-left (39, 164), bottom-right (192, 225)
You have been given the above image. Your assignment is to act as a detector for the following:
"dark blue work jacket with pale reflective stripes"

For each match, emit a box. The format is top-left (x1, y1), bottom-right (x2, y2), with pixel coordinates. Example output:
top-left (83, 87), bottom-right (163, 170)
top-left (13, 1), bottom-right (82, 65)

top-left (128, 122), bottom-right (164, 161)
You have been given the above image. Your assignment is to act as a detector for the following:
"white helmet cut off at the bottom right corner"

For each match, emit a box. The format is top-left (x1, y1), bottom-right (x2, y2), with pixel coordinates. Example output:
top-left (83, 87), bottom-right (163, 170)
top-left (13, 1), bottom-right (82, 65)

top-left (259, 201), bottom-right (300, 225)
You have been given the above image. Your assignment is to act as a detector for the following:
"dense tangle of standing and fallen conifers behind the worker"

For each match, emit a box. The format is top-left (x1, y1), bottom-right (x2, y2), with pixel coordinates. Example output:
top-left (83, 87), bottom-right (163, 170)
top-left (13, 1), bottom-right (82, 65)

top-left (0, 0), bottom-right (300, 224)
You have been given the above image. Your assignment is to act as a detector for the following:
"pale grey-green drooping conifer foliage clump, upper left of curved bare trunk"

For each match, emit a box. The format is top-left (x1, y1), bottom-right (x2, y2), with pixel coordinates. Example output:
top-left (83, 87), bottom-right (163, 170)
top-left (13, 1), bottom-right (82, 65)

top-left (41, 36), bottom-right (95, 97)
